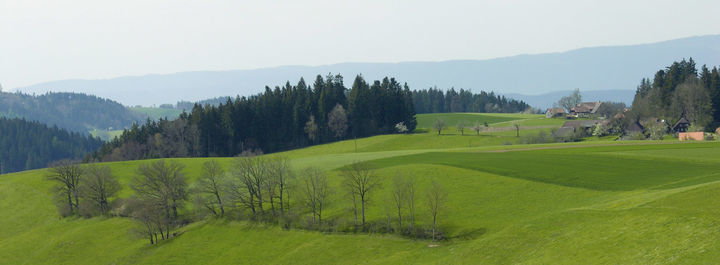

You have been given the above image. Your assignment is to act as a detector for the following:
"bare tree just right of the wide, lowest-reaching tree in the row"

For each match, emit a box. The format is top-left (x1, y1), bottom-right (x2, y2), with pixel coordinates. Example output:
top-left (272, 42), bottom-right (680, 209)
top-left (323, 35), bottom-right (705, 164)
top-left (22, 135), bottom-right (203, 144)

top-left (194, 160), bottom-right (225, 217)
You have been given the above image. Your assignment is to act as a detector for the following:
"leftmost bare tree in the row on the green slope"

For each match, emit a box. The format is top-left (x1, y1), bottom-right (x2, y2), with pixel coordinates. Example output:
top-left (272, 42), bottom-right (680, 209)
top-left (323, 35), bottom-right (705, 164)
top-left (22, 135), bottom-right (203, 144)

top-left (47, 160), bottom-right (83, 214)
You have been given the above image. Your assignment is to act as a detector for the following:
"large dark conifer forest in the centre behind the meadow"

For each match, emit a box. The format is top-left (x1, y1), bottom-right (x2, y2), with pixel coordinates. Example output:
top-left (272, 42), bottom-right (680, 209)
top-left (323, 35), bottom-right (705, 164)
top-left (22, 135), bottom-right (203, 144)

top-left (93, 75), bottom-right (417, 161)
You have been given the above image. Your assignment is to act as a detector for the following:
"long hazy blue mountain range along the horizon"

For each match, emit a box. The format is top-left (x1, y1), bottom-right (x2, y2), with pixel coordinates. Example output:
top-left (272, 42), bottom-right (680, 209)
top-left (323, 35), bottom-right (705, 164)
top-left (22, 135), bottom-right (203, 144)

top-left (18, 35), bottom-right (720, 107)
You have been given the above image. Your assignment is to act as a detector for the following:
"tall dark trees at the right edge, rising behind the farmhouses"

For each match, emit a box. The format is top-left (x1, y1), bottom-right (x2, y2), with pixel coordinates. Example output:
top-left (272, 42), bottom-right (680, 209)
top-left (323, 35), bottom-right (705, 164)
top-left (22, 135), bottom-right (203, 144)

top-left (628, 58), bottom-right (720, 129)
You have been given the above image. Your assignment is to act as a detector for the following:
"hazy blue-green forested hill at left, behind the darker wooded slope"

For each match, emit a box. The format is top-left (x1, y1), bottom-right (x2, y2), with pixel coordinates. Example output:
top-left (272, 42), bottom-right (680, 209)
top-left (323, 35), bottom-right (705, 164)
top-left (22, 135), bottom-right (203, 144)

top-left (0, 92), bottom-right (143, 132)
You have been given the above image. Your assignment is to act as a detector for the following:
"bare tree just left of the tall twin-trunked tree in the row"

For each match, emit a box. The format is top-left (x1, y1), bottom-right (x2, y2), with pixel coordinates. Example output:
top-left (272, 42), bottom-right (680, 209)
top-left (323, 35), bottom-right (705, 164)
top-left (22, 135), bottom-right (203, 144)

top-left (302, 168), bottom-right (330, 224)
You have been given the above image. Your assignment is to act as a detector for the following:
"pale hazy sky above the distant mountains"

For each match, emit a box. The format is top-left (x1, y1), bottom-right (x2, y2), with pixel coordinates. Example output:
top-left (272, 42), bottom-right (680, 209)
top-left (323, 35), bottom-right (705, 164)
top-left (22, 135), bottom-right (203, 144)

top-left (0, 0), bottom-right (720, 89)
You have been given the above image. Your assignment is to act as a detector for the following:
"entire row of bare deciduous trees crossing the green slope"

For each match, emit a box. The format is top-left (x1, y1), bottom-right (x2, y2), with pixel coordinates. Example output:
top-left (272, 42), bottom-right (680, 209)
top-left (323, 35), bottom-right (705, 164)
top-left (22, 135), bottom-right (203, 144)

top-left (47, 158), bottom-right (448, 244)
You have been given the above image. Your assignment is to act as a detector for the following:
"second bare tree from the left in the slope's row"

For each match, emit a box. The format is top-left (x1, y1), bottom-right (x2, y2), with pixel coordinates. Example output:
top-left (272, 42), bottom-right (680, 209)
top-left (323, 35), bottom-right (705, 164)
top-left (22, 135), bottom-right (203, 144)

top-left (80, 165), bottom-right (122, 215)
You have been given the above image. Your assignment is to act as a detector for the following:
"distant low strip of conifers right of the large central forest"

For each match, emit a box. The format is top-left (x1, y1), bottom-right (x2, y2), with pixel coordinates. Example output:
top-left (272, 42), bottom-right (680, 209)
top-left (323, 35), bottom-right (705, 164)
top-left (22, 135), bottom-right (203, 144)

top-left (412, 88), bottom-right (530, 113)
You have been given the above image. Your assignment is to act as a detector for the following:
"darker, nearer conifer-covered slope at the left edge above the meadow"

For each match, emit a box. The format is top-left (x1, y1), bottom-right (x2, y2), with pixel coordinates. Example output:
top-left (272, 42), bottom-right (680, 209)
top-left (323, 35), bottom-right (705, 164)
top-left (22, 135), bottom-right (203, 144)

top-left (0, 117), bottom-right (102, 173)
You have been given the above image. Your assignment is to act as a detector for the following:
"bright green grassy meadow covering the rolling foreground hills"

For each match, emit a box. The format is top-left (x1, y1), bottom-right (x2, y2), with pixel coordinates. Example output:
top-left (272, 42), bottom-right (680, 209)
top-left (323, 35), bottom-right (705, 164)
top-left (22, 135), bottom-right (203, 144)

top-left (0, 114), bottom-right (720, 264)
